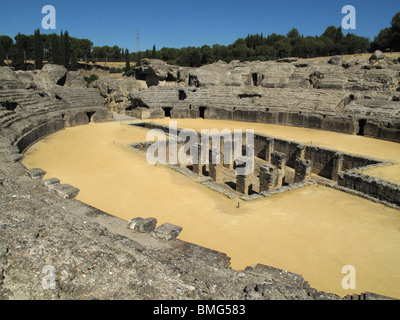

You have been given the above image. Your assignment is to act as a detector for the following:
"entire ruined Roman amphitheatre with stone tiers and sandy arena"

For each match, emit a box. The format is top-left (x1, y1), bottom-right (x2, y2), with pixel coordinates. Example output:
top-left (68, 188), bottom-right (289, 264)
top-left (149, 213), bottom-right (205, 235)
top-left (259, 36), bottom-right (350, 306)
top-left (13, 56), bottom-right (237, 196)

top-left (0, 52), bottom-right (400, 300)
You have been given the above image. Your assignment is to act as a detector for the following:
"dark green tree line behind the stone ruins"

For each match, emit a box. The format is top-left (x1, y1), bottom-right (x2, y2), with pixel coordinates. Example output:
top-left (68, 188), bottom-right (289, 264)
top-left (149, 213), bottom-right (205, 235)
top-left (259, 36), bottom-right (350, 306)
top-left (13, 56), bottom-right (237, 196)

top-left (0, 12), bottom-right (400, 71)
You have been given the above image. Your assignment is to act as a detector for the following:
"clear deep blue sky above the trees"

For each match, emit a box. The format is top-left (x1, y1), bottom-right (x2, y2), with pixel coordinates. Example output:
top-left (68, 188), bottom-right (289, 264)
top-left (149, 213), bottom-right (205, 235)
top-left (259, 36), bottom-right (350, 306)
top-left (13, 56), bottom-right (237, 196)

top-left (0, 0), bottom-right (400, 52)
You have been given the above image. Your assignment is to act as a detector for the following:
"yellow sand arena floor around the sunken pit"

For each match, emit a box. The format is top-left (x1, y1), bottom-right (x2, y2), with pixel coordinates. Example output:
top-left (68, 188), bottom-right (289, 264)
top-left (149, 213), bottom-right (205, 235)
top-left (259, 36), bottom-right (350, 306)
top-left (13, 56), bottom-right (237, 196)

top-left (23, 120), bottom-right (400, 298)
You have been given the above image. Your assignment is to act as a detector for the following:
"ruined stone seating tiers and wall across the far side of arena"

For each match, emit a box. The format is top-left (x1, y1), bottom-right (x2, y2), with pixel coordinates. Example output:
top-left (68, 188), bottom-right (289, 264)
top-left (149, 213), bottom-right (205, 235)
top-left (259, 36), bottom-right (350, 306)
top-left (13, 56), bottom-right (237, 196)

top-left (93, 53), bottom-right (400, 142)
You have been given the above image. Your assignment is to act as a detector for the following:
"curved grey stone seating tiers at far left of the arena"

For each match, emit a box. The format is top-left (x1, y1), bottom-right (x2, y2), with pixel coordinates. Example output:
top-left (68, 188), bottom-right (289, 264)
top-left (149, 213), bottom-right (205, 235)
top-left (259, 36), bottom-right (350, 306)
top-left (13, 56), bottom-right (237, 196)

top-left (0, 65), bottom-right (110, 152)
